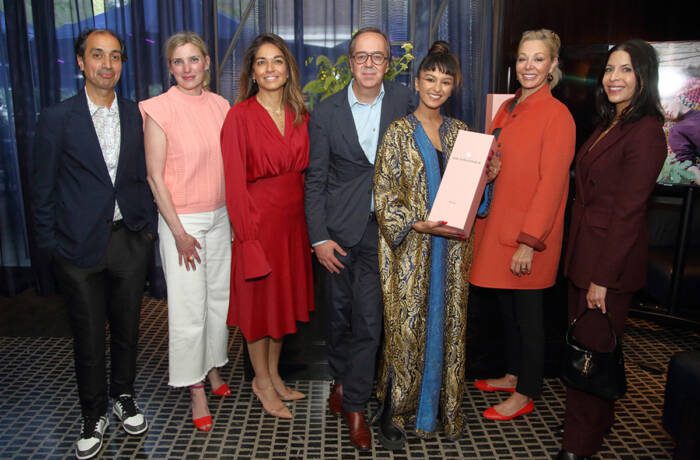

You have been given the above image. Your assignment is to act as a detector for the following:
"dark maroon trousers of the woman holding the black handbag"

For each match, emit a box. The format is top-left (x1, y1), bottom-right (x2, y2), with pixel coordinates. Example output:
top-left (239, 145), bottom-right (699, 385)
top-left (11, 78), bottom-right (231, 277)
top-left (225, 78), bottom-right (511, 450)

top-left (562, 282), bottom-right (632, 456)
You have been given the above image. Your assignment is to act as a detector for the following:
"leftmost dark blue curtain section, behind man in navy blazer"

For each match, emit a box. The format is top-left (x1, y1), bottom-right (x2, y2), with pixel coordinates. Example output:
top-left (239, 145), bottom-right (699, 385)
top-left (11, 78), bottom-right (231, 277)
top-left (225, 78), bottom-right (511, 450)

top-left (0, 0), bottom-right (216, 296)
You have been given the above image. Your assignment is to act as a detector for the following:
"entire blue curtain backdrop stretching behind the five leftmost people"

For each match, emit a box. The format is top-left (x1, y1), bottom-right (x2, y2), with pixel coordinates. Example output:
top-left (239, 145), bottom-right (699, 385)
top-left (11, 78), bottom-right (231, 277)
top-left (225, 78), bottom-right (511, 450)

top-left (0, 0), bottom-right (493, 295)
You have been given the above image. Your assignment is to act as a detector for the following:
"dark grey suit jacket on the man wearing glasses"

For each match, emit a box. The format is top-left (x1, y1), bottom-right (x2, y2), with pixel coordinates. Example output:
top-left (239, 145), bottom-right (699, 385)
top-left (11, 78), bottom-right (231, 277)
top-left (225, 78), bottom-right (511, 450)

top-left (304, 81), bottom-right (415, 248)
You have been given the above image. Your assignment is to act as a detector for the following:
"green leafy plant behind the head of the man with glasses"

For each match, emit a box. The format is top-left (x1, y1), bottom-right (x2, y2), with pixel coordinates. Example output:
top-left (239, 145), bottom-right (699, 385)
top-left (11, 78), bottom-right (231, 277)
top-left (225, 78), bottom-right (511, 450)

top-left (302, 42), bottom-right (415, 109)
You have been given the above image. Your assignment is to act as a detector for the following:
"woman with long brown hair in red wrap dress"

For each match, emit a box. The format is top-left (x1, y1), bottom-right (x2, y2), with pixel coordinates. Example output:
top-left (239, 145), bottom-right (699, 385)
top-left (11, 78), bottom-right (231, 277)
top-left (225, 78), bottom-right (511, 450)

top-left (221, 34), bottom-right (314, 418)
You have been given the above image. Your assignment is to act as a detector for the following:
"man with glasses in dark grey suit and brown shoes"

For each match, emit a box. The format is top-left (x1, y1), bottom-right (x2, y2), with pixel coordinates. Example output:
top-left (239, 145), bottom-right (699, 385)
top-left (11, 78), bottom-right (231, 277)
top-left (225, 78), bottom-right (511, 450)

top-left (305, 28), bottom-right (415, 450)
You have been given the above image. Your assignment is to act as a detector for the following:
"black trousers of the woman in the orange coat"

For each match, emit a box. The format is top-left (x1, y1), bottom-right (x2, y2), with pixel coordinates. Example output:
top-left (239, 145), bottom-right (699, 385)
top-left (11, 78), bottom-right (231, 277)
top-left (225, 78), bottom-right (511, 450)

top-left (496, 289), bottom-right (544, 398)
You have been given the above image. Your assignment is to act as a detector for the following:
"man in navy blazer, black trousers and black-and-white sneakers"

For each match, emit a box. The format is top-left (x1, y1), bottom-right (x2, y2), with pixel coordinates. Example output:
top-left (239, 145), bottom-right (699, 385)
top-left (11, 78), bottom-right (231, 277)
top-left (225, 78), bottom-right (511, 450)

top-left (32, 29), bottom-right (156, 459)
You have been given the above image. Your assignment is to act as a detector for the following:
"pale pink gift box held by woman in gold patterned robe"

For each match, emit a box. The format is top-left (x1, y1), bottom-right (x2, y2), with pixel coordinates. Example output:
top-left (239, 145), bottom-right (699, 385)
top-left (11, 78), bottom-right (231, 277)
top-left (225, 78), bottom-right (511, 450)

top-left (428, 131), bottom-right (494, 235)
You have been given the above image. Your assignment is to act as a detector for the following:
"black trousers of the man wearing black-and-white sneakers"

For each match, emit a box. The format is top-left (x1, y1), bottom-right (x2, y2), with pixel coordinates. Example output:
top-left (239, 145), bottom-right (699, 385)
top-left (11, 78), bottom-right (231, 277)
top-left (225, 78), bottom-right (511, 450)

top-left (53, 226), bottom-right (153, 417)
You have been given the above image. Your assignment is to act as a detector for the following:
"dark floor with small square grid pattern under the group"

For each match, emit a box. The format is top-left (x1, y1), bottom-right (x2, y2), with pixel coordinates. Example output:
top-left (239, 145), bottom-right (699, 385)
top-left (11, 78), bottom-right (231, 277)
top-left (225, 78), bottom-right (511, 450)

top-left (0, 298), bottom-right (700, 459)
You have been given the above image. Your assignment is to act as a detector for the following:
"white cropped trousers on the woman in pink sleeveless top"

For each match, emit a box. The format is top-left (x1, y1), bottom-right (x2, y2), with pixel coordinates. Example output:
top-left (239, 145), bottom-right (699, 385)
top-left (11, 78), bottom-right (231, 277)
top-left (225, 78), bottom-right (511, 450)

top-left (158, 207), bottom-right (231, 387)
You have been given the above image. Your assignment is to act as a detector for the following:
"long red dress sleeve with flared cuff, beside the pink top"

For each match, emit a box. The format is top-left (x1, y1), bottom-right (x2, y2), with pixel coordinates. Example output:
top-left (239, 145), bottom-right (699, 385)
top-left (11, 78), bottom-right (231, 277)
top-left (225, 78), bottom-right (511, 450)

top-left (221, 107), bottom-right (272, 280)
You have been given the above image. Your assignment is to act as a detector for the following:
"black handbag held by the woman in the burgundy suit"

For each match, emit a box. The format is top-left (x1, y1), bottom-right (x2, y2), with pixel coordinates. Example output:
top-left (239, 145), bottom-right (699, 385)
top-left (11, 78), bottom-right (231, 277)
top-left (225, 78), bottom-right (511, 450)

top-left (562, 308), bottom-right (627, 401)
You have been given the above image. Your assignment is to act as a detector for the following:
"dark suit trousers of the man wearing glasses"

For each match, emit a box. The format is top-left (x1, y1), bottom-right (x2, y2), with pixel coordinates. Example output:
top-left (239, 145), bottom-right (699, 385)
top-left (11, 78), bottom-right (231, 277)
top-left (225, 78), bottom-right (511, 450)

top-left (326, 218), bottom-right (383, 412)
